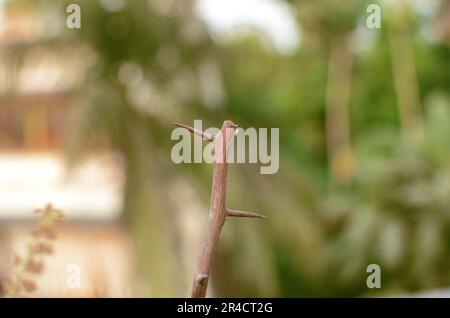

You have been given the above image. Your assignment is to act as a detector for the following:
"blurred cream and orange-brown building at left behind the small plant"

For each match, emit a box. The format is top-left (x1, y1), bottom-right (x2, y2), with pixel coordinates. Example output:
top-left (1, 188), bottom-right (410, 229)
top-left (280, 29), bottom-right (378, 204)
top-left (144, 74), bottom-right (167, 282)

top-left (0, 5), bottom-right (133, 297)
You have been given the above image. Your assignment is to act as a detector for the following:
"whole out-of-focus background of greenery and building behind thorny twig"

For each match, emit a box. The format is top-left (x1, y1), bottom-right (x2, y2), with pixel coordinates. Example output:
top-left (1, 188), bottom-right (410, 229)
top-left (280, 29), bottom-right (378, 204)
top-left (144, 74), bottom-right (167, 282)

top-left (0, 0), bottom-right (450, 297)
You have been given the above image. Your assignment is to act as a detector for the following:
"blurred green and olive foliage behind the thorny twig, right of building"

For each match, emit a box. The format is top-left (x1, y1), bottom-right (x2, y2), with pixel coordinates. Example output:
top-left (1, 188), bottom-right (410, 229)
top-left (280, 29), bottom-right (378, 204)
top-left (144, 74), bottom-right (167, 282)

top-left (7, 0), bottom-right (450, 297)
